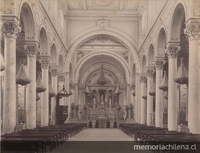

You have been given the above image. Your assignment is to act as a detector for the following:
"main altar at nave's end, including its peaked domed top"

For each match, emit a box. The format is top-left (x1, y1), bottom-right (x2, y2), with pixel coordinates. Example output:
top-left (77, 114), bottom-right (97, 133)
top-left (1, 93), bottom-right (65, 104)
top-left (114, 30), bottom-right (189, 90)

top-left (85, 65), bottom-right (120, 126)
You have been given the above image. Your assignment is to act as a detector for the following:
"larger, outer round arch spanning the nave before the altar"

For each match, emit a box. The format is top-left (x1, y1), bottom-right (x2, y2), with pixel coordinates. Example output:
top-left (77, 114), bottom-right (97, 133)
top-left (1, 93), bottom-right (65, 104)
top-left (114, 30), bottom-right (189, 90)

top-left (66, 31), bottom-right (140, 71)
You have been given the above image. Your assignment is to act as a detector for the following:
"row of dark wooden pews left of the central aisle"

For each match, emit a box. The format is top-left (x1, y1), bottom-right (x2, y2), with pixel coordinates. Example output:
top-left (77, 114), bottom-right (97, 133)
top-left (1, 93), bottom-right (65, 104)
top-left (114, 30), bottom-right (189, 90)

top-left (1, 123), bottom-right (87, 153)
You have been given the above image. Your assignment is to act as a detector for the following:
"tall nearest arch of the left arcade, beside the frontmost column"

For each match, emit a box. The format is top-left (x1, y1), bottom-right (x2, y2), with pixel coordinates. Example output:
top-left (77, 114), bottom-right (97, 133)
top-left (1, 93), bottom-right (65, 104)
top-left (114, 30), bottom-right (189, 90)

top-left (17, 1), bottom-right (37, 40)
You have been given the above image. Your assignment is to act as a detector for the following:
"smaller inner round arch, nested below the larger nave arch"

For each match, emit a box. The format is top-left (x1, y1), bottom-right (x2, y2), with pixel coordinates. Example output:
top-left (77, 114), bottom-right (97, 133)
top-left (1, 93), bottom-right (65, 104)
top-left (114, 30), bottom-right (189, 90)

top-left (74, 51), bottom-right (130, 84)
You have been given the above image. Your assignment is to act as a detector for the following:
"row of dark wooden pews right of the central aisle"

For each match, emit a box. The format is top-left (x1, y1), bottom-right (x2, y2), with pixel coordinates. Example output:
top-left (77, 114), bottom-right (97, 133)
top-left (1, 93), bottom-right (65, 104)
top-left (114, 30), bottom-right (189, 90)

top-left (119, 123), bottom-right (200, 152)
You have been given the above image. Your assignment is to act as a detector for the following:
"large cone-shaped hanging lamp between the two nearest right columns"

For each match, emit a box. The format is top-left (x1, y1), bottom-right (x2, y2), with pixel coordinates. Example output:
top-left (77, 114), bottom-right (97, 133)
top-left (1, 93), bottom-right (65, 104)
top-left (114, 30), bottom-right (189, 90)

top-left (174, 58), bottom-right (188, 84)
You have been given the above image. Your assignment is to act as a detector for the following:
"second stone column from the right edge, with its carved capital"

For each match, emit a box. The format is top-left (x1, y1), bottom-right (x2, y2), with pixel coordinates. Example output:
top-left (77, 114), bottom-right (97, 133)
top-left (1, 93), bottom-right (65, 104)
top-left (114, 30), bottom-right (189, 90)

top-left (166, 43), bottom-right (180, 131)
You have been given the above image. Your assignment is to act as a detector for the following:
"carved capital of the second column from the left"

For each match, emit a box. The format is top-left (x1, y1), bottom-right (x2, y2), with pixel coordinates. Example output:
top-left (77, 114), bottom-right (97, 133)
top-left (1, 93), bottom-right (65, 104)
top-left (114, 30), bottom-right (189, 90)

top-left (24, 41), bottom-right (39, 57)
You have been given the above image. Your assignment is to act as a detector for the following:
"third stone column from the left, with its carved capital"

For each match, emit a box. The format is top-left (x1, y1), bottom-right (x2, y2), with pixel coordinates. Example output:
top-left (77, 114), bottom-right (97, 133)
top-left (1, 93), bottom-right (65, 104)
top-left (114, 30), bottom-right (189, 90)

top-left (40, 55), bottom-right (50, 127)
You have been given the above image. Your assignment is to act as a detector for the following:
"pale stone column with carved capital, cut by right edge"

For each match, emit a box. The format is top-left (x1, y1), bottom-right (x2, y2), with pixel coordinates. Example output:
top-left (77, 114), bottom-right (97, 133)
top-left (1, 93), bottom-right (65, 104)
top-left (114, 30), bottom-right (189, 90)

top-left (185, 19), bottom-right (200, 134)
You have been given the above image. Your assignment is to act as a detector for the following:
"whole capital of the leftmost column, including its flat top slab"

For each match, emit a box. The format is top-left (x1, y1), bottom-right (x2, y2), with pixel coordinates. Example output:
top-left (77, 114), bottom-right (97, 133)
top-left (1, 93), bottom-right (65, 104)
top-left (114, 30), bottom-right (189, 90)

top-left (1, 16), bottom-right (21, 39)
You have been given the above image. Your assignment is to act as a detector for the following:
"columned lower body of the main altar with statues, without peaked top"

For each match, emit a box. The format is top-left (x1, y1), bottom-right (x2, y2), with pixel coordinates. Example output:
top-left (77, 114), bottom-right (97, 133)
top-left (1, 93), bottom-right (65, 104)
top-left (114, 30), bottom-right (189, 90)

top-left (86, 87), bottom-right (119, 121)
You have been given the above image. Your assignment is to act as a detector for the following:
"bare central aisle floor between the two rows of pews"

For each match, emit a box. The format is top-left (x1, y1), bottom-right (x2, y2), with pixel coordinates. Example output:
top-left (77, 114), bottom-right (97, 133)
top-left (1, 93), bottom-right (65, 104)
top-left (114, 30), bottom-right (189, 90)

top-left (49, 128), bottom-right (150, 153)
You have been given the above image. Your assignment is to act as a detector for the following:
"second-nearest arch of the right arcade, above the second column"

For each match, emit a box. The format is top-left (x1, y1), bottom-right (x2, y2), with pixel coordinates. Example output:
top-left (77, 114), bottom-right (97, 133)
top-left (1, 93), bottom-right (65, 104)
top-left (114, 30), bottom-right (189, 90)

top-left (156, 28), bottom-right (166, 57)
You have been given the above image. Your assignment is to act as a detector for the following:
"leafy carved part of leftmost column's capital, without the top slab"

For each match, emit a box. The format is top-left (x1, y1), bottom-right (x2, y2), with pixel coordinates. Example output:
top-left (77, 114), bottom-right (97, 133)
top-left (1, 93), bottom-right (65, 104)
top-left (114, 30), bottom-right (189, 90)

top-left (1, 20), bottom-right (21, 39)
